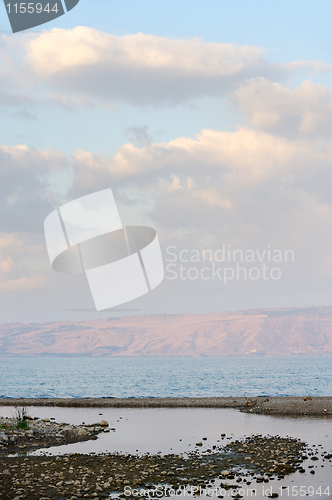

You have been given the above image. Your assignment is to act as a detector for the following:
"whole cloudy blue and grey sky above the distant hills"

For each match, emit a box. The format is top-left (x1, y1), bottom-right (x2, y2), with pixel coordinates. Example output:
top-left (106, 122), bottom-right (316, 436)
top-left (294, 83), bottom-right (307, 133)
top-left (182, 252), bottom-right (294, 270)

top-left (0, 0), bottom-right (332, 322)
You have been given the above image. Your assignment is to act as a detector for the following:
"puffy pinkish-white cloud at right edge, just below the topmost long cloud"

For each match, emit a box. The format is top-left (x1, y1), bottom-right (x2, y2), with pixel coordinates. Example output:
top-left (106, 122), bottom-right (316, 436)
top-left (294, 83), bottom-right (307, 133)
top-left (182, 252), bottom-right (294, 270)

top-left (231, 78), bottom-right (332, 136)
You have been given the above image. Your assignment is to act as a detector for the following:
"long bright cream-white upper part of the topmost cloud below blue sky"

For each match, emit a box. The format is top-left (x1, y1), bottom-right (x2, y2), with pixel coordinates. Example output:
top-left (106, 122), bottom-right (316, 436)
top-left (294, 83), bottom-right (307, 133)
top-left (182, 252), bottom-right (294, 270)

top-left (27, 27), bottom-right (264, 78)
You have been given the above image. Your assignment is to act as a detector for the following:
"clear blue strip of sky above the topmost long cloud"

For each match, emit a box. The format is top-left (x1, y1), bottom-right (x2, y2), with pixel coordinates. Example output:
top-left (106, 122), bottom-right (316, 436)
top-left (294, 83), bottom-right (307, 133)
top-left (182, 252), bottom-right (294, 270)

top-left (0, 0), bottom-right (332, 57)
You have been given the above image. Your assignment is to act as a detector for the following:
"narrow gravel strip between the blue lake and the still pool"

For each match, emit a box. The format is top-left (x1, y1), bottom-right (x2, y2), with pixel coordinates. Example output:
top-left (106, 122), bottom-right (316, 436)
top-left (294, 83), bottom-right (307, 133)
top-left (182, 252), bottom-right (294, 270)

top-left (0, 396), bottom-right (332, 418)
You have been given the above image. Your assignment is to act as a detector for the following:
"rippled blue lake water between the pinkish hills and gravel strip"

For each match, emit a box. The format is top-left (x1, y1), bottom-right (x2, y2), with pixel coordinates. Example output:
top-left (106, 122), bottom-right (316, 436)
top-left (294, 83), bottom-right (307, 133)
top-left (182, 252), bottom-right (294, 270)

top-left (0, 356), bottom-right (332, 398)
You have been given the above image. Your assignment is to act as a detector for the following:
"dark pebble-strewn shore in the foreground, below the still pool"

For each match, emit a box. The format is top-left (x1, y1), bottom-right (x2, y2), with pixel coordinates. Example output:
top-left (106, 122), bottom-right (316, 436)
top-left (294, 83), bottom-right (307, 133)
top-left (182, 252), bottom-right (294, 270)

top-left (0, 434), bottom-right (332, 500)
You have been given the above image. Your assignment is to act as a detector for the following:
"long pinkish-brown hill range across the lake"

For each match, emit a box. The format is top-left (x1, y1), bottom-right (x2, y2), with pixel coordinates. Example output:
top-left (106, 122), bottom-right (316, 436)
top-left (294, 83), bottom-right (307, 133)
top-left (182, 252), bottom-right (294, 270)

top-left (0, 306), bottom-right (332, 356)
